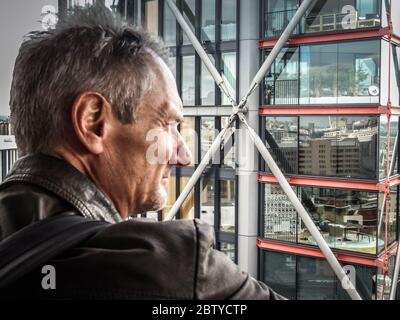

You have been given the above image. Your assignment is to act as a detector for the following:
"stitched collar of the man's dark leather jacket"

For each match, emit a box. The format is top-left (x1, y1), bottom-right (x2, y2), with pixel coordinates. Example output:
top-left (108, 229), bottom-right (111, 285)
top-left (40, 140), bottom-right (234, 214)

top-left (0, 154), bottom-right (122, 223)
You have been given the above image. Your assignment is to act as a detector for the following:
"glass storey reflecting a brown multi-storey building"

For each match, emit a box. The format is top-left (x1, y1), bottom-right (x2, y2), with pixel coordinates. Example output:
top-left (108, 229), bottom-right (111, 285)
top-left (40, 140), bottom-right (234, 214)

top-left (264, 115), bottom-right (382, 180)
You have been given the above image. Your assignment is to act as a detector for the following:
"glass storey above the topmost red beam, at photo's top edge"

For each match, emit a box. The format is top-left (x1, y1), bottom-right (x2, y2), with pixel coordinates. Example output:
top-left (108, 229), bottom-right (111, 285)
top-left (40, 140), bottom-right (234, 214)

top-left (263, 0), bottom-right (381, 38)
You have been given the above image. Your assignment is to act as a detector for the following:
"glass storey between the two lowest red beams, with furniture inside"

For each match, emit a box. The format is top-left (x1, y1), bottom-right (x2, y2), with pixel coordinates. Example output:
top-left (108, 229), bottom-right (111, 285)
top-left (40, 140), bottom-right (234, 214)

top-left (263, 184), bottom-right (398, 255)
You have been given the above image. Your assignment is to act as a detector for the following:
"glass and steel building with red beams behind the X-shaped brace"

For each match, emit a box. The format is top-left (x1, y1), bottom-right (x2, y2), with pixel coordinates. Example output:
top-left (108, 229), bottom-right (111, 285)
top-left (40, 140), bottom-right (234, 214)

top-left (59, 0), bottom-right (400, 299)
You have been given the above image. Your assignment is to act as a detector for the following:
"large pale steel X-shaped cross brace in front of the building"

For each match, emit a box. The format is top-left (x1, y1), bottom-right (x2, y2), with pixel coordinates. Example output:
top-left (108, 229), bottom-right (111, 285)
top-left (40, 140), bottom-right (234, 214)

top-left (164, 0), bottom-right (361, 300)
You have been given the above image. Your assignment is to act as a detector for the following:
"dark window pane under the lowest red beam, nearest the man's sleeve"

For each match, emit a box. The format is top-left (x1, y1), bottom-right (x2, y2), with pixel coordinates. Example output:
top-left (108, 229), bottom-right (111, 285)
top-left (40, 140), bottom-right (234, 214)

top-left (263, 251), bottom-right (296, 299)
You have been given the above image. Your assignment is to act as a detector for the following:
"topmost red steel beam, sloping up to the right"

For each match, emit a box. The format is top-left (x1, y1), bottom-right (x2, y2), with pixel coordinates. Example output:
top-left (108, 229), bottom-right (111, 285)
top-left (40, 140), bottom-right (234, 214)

top-left (259, 27), bottom-right (393, 48)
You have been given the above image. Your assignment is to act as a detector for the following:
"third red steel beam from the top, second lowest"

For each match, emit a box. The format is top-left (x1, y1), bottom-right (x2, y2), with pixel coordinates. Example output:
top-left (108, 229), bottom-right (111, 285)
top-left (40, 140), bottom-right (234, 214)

top-left (258, 173), bottom-right (382, 191)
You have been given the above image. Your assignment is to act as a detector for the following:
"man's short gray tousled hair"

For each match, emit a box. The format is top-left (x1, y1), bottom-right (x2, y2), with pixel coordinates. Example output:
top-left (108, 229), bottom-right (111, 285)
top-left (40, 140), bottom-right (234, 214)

top-left (10, 5), bottom-right (168, 155)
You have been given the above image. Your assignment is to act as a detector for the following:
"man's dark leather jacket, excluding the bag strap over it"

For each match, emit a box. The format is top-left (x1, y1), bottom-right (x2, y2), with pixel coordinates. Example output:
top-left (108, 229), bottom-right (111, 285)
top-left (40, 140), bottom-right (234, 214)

top-left (0, 155), bottom-right (280, 299)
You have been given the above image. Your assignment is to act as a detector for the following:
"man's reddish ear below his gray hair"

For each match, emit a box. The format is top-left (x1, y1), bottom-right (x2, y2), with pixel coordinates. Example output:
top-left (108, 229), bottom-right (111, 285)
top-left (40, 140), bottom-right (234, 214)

top-left (71, 92), bottom-right (111, 154)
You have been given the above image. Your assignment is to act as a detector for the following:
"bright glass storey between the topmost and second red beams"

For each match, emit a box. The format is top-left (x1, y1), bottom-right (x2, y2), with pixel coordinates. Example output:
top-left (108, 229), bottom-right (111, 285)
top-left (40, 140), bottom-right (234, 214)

top-left (263, 40), bottom-right (380, 105)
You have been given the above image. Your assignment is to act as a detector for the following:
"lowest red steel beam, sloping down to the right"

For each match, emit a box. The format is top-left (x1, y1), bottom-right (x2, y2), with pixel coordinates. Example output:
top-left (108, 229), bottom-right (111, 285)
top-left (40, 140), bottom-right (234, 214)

top-left (257, 238), bottom-right (380, 267)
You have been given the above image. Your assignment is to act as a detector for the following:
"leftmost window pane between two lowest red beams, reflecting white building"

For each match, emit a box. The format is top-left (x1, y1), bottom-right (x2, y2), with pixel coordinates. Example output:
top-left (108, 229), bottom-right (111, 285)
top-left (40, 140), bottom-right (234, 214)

top-left (264, 184), bottom-right (300, 242)
